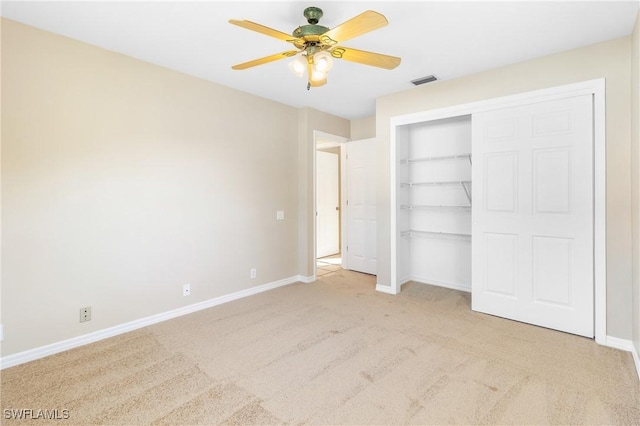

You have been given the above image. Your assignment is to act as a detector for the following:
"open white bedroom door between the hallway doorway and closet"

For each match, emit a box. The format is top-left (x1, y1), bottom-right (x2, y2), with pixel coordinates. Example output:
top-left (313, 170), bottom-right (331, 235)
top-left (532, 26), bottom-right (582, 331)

top-left (346, 139), bottom-right (378, 275)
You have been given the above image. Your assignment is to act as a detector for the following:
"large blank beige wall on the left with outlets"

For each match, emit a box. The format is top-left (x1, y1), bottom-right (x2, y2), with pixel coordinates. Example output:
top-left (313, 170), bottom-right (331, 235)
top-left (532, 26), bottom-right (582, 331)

top-left (1, 20), bottom-right (306, 356)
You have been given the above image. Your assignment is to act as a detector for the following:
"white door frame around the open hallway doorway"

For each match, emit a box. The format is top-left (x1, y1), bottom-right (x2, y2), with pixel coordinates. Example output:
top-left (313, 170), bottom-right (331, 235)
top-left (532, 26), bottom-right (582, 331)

top-left (313, 130), bottom-right (350, 281)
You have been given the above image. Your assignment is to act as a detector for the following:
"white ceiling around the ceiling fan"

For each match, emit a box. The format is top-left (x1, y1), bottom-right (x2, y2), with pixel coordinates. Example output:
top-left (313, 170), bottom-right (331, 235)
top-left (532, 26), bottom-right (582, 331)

top-left (1, 0), bottom-right (640, 119)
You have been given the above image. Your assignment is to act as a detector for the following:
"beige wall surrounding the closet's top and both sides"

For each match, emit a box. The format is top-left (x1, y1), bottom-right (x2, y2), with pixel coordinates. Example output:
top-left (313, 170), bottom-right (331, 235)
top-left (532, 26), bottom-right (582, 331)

top-left (376, 37), bottom-right (632, 339)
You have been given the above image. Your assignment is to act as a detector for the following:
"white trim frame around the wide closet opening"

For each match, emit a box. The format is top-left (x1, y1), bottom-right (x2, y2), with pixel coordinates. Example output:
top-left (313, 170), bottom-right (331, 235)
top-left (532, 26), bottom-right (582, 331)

top-left (388, 78), bottom-right (607, 345)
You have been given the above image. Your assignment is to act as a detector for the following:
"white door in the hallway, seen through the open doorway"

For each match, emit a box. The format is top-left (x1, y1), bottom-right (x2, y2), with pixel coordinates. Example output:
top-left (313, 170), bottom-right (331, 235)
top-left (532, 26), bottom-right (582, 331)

top-left (316, 151), bottom-right (340, 257)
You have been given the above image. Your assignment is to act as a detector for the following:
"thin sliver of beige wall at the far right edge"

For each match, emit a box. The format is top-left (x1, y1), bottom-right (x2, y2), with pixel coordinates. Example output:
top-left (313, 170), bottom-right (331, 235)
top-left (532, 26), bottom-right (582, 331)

top-left (631, 13), bottom-right (640, 356)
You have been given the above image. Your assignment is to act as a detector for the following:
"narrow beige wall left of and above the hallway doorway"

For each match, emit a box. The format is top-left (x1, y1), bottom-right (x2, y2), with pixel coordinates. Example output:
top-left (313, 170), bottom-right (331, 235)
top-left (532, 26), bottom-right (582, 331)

top-left (298, 108), bottom-right (351, 277)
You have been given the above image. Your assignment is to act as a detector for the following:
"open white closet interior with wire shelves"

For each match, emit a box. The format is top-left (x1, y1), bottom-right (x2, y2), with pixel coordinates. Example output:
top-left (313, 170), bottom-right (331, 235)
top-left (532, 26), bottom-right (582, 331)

top-left (395, 115), bottom-right (473, 291)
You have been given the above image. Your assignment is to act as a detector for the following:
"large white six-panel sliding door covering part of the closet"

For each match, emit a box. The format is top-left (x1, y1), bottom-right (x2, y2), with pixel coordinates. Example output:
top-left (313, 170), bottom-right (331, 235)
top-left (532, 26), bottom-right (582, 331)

top-left (472, 95), bottom-right (594, 337)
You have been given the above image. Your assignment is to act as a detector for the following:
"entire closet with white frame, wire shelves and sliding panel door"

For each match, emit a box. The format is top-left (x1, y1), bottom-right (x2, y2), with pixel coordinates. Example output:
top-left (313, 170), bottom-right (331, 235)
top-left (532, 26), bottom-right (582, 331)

top-left (390, 80), bottom-right (606, 339)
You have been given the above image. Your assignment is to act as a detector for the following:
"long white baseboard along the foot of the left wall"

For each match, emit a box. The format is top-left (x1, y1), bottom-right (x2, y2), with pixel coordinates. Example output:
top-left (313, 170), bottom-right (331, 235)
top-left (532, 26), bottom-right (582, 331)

top-left (0, 275), bottom-right (302, 370)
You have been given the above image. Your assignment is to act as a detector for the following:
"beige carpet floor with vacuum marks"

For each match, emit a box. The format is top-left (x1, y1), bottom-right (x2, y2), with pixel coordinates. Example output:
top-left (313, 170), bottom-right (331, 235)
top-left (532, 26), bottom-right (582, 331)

top-left (1, 271), bottom-right (640, 425)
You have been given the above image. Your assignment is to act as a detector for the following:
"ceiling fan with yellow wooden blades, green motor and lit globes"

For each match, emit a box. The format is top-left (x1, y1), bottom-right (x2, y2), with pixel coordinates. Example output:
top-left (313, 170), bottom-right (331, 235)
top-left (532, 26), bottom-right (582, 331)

top-left (229, 7), bottom-right (400, 90)
